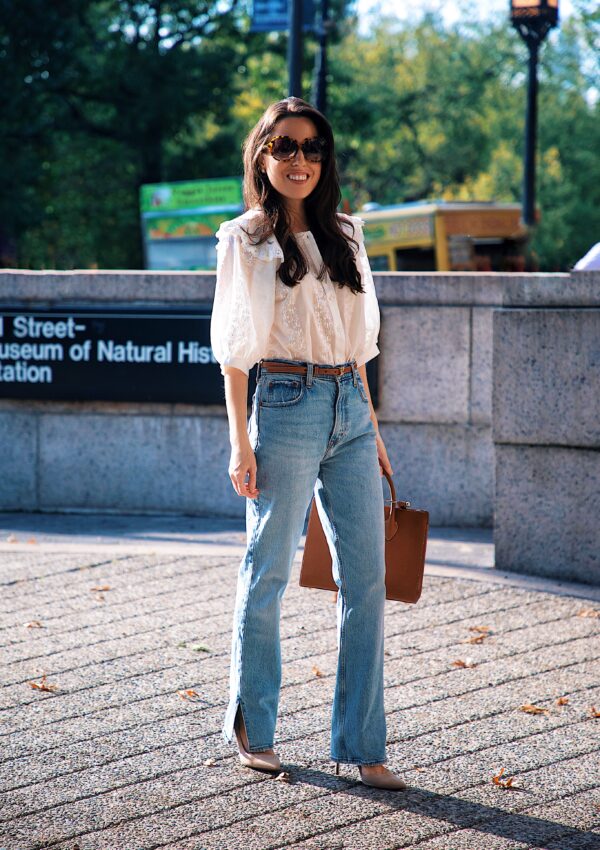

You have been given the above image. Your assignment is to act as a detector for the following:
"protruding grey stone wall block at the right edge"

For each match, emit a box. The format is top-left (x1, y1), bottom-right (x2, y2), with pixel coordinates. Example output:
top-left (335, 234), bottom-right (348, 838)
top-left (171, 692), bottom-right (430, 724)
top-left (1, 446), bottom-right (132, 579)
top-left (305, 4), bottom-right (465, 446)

top-left (493, 272), bottom-right (600, 584)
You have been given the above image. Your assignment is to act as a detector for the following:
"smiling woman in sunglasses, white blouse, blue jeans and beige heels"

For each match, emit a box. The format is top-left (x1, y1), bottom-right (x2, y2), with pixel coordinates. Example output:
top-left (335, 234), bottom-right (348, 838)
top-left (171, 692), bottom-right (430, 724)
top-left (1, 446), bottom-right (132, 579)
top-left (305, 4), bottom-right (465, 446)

top-left (211, 97), bottom-right (406, 789)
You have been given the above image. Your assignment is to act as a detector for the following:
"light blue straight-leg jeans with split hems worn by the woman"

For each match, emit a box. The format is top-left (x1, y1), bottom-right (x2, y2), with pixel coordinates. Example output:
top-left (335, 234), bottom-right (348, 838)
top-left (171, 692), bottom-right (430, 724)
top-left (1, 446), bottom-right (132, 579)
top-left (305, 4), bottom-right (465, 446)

top-left (222, 358), bottom-right (386, 764)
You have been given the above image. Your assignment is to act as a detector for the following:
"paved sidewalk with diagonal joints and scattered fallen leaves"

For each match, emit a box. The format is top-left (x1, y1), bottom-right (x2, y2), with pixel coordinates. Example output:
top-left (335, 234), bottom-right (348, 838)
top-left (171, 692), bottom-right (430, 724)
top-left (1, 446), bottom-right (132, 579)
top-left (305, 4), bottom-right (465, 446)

top-left (0, 530), bottom-right (600, 850)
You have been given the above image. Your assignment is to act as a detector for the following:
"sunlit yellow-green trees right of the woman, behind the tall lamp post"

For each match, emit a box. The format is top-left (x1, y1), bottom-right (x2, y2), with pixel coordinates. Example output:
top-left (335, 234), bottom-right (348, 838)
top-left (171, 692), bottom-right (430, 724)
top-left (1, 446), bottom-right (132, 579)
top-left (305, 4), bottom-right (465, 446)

top-left (331, 9), bottom-right (600, 270)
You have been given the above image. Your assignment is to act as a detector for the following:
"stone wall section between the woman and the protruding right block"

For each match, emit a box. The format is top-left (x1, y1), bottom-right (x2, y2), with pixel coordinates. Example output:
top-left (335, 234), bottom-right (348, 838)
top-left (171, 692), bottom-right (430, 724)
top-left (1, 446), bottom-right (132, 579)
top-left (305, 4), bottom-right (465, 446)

top-left (377, 273), bottom-right (503, 526)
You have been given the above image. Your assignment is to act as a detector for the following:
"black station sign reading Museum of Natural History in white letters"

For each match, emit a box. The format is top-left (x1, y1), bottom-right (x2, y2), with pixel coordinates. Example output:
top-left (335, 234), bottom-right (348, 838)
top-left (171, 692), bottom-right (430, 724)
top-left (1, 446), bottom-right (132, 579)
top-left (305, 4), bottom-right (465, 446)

top-left (0, 307), bottom-right (377, 405)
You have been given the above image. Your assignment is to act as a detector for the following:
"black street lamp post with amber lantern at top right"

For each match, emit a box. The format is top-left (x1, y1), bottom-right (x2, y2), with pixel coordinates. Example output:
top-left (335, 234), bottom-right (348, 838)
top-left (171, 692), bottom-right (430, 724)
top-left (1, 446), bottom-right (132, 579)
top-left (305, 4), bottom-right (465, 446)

top-left (510, 0), bottom-right (558, 226)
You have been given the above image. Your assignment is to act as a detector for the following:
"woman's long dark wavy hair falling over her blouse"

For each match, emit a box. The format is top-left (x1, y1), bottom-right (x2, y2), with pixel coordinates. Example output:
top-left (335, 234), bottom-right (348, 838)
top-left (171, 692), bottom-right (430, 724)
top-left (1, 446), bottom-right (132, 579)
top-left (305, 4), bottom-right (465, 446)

top-left (242, 97), bottom-right (365, 293)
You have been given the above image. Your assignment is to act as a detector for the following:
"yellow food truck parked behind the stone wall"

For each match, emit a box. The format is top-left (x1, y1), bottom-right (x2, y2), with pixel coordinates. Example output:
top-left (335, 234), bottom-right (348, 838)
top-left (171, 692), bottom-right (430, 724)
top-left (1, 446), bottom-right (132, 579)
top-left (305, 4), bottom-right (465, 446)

top-left (355, 201), bottom-right (529, 271)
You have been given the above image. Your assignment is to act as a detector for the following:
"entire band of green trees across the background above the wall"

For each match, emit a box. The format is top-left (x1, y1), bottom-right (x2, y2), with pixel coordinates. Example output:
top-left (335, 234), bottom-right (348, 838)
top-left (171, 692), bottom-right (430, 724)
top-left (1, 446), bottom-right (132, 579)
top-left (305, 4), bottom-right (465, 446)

top-left (0, 0), bottom-right (600, 270)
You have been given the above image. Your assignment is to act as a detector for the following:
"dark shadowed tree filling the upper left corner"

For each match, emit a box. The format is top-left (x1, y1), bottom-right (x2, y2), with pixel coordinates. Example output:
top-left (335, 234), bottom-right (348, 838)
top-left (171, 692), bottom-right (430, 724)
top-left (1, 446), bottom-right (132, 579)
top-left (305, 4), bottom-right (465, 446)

top-left (0, 0), bottom-right (241, 265)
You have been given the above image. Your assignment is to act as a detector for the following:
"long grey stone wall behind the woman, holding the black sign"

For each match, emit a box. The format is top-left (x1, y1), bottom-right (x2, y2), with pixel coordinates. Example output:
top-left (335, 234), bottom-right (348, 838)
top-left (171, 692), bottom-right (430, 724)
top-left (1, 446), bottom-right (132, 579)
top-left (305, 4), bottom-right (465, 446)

top-left (0, 271), bottom-right (569, 526)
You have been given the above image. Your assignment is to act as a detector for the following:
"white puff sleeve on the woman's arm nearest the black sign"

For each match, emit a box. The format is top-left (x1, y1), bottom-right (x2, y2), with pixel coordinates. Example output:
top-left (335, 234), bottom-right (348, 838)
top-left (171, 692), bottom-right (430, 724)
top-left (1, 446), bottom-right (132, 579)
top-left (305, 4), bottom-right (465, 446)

top-left (210, 221), bottom-right (283, 375)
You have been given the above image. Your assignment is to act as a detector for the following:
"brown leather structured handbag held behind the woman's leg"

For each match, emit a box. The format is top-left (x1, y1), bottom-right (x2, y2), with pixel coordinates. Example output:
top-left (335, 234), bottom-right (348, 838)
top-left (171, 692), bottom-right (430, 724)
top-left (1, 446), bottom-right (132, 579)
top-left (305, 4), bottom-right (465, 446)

top-left (300, 470), bottom-right (429, 602)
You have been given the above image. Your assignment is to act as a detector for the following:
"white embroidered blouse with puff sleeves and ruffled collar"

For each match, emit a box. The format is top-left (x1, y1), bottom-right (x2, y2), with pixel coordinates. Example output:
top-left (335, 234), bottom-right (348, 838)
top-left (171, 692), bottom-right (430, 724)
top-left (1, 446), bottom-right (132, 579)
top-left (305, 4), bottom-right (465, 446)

top-left (210, 209), bottom-right (380, 375)
